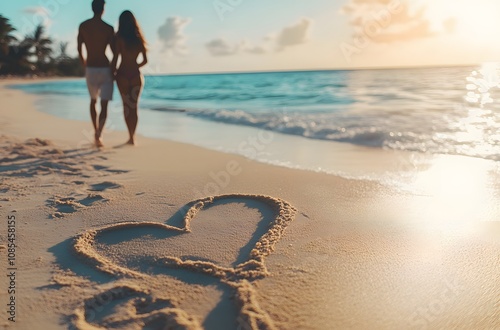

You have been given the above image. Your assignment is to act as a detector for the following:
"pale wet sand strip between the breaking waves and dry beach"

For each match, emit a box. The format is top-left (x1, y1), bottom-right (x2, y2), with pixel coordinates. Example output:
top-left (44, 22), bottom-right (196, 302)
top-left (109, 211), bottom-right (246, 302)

top-left (4, 79), bottom-right (497, 190)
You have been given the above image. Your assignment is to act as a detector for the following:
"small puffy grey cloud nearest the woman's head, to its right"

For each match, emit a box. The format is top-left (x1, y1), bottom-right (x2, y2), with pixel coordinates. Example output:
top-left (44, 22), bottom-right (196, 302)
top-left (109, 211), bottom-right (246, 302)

top-left (158, 16), bottom-right (191, 55)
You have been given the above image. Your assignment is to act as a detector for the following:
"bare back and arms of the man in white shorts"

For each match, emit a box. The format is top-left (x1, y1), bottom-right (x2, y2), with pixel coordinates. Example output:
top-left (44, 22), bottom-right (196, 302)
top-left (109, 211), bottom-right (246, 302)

top-left (78, 17), bottom-right (115, 68)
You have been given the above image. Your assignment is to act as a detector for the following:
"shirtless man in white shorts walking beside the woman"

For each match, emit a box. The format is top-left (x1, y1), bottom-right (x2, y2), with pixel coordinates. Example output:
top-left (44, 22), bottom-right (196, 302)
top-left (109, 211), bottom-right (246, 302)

top-left (78, 0), bottom-right (115, 147)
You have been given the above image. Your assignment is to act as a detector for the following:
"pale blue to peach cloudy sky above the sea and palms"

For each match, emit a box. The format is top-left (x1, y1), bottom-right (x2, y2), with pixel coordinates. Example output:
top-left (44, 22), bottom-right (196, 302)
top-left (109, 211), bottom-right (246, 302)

top-left (0, 0), bottom-right (500, 74)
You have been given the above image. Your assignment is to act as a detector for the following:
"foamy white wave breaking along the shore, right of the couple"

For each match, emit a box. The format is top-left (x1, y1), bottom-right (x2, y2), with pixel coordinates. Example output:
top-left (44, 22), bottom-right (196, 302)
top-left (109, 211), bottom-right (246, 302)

top-left (177, 110), bottom-right (500, 161)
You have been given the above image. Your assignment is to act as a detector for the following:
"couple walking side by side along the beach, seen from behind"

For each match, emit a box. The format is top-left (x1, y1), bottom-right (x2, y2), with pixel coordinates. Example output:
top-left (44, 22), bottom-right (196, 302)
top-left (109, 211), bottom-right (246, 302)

top-left (78, 0), bottom-right (148, 147)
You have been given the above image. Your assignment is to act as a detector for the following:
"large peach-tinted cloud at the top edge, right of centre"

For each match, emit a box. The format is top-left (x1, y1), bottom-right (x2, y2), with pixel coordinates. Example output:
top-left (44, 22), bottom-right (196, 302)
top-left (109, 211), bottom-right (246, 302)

top-left (342, 0), bottom-right (436, 43)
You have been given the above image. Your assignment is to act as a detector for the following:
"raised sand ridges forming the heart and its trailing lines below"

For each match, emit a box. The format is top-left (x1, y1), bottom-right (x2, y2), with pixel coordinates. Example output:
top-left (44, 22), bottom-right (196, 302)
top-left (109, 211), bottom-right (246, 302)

top-left (73, 194), bottom-right (297, 330)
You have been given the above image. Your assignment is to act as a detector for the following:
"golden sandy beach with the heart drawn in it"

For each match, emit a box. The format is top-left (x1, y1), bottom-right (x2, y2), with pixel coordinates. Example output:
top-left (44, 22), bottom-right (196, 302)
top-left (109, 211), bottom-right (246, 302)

top-left (0, 81), bottom-right (500, 329)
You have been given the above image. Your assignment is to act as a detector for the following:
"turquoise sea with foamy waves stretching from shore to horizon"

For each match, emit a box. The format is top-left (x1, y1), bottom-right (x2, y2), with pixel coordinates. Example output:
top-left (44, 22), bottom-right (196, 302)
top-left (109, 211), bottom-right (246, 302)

top-left (10, 65), bottom-right (500, 161)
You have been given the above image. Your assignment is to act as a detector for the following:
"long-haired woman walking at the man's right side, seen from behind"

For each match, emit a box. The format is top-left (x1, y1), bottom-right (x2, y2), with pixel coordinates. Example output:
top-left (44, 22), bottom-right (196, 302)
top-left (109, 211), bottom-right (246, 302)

top-left (111, 10), bottom-right (148, 145)
